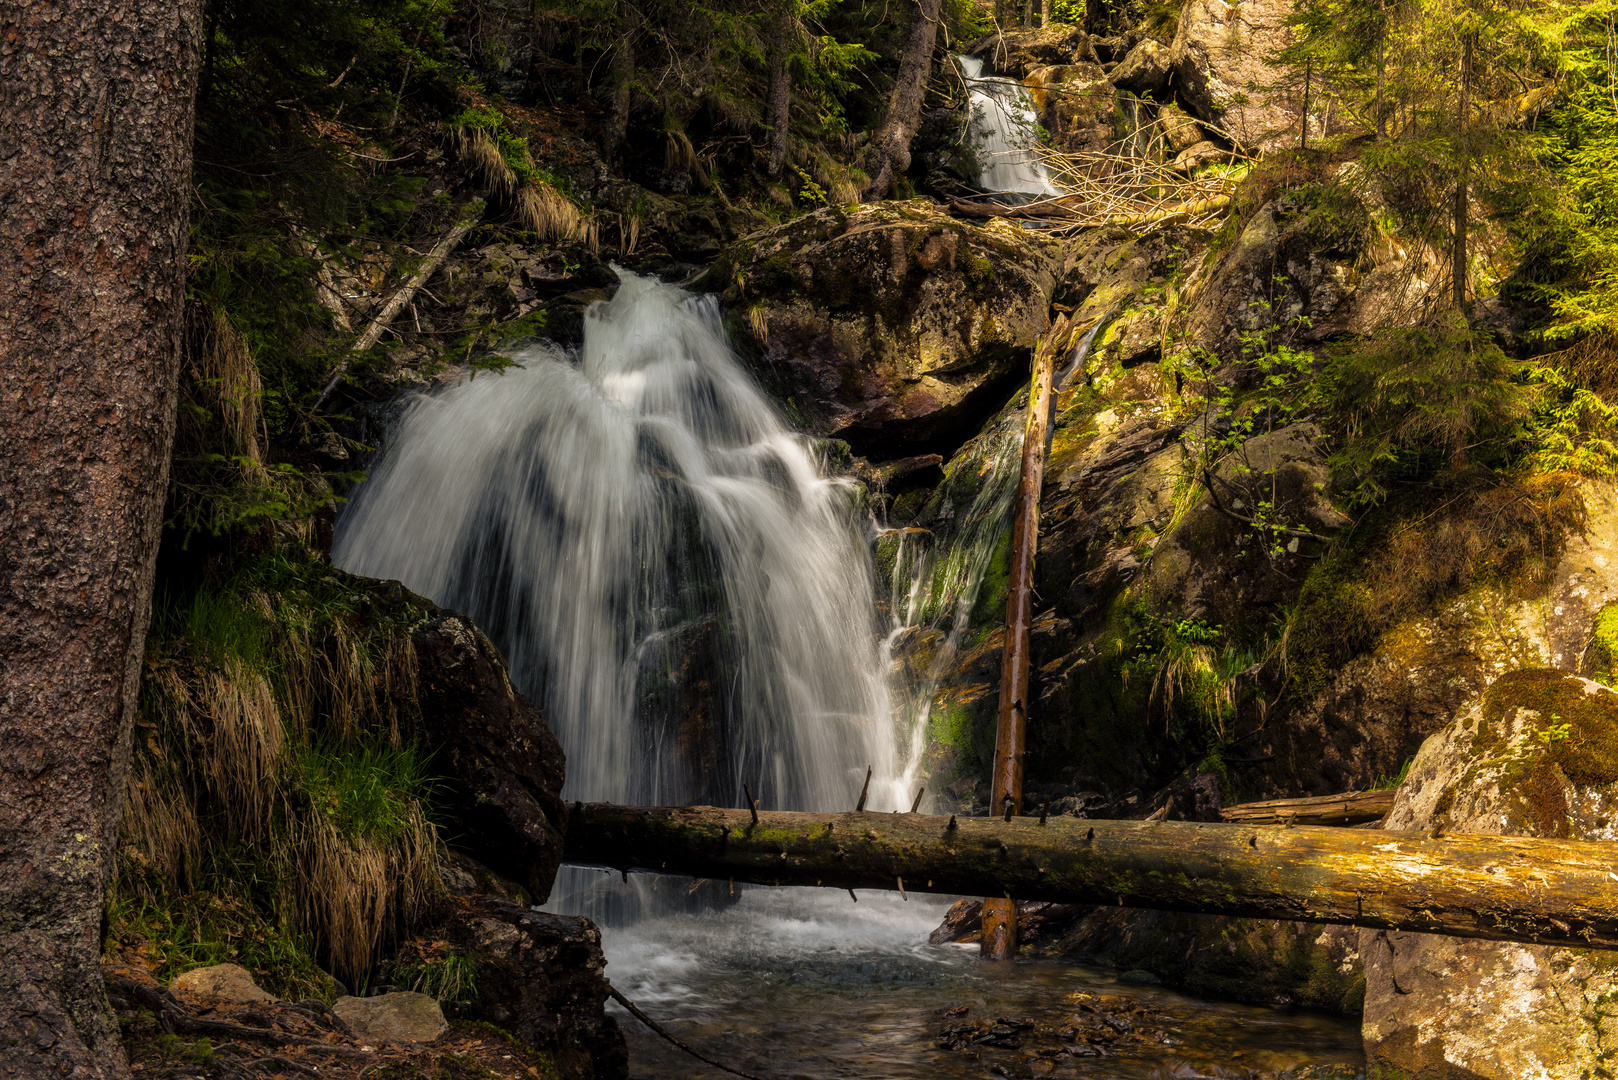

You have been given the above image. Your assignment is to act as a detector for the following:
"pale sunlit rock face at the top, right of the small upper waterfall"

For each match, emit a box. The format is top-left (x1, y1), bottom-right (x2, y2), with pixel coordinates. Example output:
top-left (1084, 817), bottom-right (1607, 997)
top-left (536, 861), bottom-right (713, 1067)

top-left (1170, 0), bottom-right (1302, 152)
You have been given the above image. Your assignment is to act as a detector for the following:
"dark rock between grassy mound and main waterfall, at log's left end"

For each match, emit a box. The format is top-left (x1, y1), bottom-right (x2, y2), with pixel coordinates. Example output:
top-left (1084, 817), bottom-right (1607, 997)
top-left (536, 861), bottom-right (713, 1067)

top-left (407, 605), bottom-right (566, 902)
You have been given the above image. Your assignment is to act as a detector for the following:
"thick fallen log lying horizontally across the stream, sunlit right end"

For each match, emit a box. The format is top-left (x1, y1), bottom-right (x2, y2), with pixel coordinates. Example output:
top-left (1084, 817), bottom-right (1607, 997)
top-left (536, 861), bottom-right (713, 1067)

top-left (565, 803), bottom-right (1618, 949)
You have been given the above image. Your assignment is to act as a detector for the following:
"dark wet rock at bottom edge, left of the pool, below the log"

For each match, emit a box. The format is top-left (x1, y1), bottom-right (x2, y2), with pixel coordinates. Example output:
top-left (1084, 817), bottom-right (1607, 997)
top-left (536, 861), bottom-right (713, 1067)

top-left (462, 897), bottom-right (629, 1080)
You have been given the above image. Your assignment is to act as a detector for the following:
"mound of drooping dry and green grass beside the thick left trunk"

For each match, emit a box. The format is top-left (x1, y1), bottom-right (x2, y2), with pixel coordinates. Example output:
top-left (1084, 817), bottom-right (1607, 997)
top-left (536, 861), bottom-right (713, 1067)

top-left (112, 552), bottom-right (438, 984)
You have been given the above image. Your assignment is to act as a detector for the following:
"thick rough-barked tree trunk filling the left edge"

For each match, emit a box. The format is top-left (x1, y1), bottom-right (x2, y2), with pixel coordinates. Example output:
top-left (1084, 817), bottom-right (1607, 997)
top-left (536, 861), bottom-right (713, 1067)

top-left (0, 0), bottom-right (202, 1080)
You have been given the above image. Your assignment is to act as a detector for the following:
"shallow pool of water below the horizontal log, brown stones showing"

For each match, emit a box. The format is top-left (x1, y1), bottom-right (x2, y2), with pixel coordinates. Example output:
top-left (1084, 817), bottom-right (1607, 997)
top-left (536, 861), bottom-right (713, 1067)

top-left (602, 879), bottom-right (1364, 1080)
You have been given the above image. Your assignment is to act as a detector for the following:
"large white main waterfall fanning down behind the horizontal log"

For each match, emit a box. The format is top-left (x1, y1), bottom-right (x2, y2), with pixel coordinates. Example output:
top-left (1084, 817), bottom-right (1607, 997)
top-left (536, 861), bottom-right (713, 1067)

top-left (333, 270), bottom-right (909, 835)
